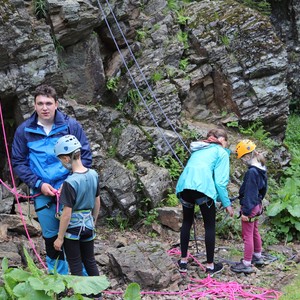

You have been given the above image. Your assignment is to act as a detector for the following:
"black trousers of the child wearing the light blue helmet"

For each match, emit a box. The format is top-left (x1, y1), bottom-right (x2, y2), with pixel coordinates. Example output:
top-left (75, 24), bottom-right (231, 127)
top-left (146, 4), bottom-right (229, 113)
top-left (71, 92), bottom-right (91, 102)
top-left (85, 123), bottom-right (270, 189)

top-left (64, 238), bottom-right (99, 276)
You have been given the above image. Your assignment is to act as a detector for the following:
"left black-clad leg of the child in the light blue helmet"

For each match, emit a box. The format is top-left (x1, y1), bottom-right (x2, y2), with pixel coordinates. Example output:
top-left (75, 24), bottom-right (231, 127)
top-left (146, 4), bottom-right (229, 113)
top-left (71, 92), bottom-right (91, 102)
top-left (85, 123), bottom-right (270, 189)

top-left (64, 238), bottom-right (83, 276)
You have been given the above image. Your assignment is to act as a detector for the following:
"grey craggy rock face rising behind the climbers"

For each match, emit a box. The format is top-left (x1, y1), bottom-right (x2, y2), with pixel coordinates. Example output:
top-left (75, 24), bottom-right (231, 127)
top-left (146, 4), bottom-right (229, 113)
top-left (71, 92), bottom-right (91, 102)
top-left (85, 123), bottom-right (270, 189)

top-left (0, 0), bottom-right (299, 222)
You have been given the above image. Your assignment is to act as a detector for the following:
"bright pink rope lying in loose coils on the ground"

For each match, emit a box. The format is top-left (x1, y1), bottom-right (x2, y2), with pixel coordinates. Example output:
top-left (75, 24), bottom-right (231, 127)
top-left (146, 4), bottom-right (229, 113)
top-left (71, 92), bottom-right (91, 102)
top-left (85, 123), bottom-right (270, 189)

top-left (103, 248), bottom-right (282, 300)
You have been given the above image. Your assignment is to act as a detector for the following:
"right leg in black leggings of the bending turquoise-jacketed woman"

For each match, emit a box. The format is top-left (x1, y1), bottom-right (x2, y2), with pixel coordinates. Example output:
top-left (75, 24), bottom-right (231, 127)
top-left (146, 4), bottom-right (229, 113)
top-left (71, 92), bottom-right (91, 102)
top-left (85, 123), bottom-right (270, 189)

top-left (200, 200), bottom-right (216, 265)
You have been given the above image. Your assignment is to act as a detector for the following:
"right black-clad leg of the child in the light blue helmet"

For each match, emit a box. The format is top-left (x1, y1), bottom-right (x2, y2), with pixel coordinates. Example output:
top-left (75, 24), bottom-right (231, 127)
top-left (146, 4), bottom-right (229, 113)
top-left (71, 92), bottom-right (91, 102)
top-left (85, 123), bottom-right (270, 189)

top-left (80, 240), bottom-right (99, 276)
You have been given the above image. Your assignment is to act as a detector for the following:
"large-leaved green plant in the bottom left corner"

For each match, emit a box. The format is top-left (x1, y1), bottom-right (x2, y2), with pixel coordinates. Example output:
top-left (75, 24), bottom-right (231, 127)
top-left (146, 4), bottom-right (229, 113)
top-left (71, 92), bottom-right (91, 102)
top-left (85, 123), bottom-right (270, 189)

top-left (0, 248), bottom-right (109, 300)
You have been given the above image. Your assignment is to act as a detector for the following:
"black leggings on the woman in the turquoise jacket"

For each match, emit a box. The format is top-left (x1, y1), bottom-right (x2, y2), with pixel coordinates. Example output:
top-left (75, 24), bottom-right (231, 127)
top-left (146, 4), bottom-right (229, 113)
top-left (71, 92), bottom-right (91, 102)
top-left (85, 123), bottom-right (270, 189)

top-left (180, 190), bottom-right (216, 263)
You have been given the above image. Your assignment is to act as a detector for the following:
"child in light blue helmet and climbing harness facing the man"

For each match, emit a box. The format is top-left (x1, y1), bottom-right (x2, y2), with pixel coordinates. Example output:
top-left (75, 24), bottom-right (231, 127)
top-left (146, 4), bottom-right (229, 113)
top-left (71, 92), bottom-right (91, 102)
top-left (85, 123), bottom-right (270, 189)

top-left (54, 135), bottom-right (100, 276)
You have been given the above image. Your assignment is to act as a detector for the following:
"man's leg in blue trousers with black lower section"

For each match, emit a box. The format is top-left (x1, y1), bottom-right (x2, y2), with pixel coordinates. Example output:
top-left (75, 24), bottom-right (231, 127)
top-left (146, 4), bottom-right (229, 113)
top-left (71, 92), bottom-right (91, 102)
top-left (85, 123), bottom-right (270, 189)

top-left (34, 195), bottom-right (69, 275)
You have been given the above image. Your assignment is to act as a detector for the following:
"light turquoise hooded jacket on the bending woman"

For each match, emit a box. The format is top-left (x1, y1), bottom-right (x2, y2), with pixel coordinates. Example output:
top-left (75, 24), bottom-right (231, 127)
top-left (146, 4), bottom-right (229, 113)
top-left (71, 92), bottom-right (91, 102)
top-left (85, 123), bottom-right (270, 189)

top-left (176, 141), bottom-right (231, 207)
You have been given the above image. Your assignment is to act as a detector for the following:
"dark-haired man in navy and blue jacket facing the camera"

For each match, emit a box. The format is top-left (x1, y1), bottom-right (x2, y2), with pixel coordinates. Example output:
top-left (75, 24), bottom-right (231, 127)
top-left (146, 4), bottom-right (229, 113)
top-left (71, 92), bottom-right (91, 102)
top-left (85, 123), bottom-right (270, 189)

top-left (12, 85), bottom-right (92, 274)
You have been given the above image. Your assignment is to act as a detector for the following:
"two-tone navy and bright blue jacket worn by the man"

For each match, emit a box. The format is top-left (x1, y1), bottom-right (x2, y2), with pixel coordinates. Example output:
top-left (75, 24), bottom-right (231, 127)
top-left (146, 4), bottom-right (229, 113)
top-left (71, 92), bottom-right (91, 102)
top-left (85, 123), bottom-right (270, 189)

top-left (12, 109), bottom-right (92, 190)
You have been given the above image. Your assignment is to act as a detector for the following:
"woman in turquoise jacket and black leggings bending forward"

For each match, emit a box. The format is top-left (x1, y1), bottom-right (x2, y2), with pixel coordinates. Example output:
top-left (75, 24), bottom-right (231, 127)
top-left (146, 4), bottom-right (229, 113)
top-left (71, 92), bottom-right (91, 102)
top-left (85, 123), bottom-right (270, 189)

top-left (176, 129), bottom-right (233, 274)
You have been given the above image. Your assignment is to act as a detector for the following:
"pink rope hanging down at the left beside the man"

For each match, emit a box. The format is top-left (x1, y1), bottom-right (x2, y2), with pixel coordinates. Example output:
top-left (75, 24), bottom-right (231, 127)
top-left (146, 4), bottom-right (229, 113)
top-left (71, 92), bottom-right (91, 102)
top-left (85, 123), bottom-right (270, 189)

top-left (0, 102), bottom-right (47, 270)
